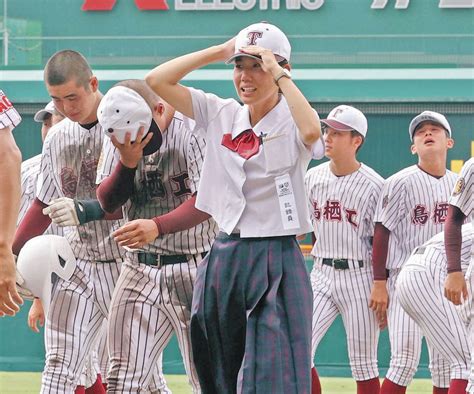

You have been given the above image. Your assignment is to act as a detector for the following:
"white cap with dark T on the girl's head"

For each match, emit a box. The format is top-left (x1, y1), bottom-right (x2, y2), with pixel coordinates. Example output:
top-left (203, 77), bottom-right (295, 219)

top-left (226, 22), bottom-right (291, 64)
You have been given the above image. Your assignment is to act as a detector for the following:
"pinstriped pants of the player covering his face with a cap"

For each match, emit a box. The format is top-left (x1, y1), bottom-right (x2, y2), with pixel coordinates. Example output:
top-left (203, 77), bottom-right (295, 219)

top-left (107, 256), bottom-right (202, 393)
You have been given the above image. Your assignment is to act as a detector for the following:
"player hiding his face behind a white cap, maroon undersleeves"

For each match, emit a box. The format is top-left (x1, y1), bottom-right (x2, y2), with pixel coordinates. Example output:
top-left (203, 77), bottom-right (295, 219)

top-left (97, 80), bottom-right (217, 393)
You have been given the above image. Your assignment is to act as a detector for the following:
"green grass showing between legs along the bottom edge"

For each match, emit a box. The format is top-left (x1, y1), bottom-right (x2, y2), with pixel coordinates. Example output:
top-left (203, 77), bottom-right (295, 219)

top-left (0, 372), bottom-right (432, 394)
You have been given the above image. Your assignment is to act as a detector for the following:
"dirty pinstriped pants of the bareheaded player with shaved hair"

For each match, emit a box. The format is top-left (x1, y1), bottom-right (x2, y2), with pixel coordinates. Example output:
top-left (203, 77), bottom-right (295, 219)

top-left (41, 260), bottom-right (120, 394)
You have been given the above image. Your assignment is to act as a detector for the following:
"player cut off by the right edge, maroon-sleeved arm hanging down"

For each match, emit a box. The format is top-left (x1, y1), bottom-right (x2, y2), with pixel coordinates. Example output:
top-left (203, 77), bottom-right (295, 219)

top-left (444, 158), bottom-right (474, 394)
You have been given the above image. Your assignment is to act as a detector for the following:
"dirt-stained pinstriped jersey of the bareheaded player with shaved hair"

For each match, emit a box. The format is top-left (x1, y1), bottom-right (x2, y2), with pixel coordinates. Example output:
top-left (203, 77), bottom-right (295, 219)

top-left (36, 118), bottom-right (122, 261)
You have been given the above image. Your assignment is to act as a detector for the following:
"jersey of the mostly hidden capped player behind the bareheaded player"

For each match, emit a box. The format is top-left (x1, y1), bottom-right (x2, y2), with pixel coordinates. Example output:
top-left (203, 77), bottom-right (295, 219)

top-left (16, 155), bottom-right (66, 236)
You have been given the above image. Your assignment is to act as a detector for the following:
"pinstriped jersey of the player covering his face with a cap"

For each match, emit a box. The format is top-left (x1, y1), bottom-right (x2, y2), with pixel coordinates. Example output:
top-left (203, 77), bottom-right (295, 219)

top-left (97, 113), bottom-right (218, 255)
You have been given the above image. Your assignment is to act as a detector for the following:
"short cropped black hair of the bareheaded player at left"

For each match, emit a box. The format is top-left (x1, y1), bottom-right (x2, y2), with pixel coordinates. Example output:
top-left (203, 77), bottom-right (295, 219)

top-left (44, 49), bottom-right (92, 89)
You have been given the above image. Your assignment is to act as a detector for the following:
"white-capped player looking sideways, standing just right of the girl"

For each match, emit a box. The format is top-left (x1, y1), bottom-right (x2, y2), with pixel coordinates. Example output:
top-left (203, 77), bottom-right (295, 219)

top-left (305, 105), bottom-right (383, 394)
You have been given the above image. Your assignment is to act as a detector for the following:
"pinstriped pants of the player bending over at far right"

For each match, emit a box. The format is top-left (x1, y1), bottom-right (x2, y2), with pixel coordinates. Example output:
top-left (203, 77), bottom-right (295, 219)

top-left (396, 255), bottom-right (470, 387)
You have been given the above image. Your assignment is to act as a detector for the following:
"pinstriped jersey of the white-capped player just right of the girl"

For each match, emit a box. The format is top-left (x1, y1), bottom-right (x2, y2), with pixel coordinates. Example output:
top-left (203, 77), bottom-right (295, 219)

top-left (305, 162), bottom-right (383, 261)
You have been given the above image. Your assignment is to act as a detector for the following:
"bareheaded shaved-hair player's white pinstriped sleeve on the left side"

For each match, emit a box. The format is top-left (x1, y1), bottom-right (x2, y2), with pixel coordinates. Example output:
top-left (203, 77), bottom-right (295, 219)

top-left (36, 135), bottom-right (62, 204)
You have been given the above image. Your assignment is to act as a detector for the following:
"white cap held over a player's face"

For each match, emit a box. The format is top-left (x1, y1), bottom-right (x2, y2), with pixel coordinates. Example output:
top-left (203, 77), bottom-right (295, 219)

top-left (97, 86), bottom-right (162, 150)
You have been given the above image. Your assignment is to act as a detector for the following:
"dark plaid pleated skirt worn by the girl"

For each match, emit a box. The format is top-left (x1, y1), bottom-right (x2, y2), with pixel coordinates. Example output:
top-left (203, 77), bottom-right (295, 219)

top-left (191, 233), bottom-right (313, 394)
